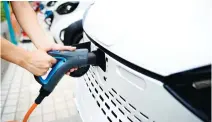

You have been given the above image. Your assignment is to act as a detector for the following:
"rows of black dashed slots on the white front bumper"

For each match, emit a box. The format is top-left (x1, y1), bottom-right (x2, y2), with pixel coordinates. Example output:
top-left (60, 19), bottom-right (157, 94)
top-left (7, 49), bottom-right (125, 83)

top-left (83, 67), bottom-right (152, 122)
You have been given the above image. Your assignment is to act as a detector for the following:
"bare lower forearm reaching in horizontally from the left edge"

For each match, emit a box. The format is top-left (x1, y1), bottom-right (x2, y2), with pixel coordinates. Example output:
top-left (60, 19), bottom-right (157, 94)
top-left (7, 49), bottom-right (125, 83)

top-left (0, 37), bottom-right (29, 67)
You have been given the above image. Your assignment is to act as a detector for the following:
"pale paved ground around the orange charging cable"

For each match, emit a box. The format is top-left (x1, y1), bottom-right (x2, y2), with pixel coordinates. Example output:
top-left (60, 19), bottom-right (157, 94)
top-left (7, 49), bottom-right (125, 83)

top-left (1, 41), bottom-right (81, 122)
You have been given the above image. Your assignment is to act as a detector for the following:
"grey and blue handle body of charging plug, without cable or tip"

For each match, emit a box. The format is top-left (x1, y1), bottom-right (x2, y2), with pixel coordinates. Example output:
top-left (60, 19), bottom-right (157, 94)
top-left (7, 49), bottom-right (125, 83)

top-left (34, 49), bottom-right (88, 92)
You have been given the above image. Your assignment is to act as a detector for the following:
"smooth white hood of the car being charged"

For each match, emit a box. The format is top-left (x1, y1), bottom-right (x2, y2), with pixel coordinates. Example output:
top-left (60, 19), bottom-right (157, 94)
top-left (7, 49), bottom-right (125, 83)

top-left (83, 0), bottom-right (212, 76)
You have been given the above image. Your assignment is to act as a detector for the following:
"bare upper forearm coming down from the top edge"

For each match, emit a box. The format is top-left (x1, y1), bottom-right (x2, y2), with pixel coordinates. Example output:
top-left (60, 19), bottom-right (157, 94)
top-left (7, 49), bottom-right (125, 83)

top-left (11, 1), bottom-right (53, 49)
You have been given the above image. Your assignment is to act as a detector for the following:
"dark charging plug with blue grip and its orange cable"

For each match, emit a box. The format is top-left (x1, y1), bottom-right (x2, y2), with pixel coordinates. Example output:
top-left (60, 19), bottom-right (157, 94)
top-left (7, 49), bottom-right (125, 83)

top-left (24, 49), bottom-right (106, 122)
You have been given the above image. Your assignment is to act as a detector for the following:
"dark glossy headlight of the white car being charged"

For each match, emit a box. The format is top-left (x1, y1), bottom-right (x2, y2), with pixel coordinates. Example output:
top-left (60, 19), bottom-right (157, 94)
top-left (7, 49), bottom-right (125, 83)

top-left (164, 65), bottom-right (211, 121)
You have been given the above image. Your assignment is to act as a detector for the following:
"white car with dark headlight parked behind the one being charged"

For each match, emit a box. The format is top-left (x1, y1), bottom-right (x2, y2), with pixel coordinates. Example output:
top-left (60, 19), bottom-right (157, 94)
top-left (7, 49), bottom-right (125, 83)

top-left (46, 0), bottom-right (93, 45)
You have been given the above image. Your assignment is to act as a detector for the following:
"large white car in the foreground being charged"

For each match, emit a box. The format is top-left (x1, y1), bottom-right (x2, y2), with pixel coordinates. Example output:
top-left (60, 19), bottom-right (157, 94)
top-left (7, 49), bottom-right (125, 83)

top-left (76, 0), bottom-right (212, 122)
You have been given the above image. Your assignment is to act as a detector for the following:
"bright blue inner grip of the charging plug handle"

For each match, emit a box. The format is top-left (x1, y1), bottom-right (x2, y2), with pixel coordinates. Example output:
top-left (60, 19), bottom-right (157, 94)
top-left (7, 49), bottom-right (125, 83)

top-left (39, 57), bottom-right (66, 84)
